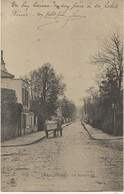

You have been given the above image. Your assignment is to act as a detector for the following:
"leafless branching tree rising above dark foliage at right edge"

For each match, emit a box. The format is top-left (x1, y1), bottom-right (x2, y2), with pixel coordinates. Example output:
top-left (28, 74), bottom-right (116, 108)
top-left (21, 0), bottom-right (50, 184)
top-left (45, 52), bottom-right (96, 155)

top-left (90, 32), bottom-right (123, 105)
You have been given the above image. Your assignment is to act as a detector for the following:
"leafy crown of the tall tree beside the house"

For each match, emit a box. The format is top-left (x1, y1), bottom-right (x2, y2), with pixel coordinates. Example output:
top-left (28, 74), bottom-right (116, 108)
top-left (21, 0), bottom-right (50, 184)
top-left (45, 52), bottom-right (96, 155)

top-left (24, 63), bottom-right (65, 128)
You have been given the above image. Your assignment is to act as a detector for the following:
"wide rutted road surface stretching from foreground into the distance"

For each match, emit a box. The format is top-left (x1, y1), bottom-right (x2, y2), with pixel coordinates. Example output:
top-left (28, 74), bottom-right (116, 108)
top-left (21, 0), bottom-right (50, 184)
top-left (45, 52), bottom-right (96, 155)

top-left (2, 120), bottom-right (123, 191)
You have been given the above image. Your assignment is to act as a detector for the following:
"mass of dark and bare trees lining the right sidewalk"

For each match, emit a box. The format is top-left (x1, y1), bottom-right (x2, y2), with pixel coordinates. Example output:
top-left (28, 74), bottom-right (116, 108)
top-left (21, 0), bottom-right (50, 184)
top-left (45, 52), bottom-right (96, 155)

top-left (83, 32), bottom-right (123, 135)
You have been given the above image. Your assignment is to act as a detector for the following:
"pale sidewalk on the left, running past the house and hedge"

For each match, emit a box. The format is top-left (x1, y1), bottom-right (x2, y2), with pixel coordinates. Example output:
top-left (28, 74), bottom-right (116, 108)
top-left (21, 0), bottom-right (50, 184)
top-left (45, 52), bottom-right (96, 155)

top-left (1, 122), bottom-right (72, 147)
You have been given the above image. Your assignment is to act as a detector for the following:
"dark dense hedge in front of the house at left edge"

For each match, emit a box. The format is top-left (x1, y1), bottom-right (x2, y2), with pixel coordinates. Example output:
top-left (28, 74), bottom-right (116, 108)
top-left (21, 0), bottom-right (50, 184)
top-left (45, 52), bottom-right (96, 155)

top-left (1, 89), bottom-right (23, 141)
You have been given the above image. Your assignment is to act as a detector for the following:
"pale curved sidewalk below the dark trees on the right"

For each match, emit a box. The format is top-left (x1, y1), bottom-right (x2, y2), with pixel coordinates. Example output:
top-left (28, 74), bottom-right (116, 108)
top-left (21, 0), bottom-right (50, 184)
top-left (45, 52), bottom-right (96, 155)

top-left (82, 121), bottom-right (123, 140)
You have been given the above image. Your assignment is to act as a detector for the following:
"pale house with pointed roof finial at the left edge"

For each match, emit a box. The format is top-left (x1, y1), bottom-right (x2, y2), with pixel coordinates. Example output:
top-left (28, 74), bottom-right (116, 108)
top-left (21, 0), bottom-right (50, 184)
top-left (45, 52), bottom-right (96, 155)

top-left (1, 51), bottom-right (37, 135)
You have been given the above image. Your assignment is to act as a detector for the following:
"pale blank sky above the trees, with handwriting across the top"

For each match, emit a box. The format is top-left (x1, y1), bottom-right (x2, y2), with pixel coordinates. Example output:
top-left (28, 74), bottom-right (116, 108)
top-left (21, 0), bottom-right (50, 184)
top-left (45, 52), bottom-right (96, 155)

top-left (1, 0), bottom-right (123, 106)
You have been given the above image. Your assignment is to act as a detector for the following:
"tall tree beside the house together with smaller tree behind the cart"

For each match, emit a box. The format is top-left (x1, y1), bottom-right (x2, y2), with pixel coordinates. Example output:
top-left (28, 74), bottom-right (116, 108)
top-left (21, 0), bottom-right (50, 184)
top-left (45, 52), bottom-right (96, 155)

top-left (24, 63), bottom-right (75, 130)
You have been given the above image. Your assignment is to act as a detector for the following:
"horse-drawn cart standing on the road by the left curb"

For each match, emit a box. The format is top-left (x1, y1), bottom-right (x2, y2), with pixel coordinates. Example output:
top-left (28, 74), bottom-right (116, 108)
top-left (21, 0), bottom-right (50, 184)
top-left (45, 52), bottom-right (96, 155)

top-left (45, 121), bottom-right (62, 138)
